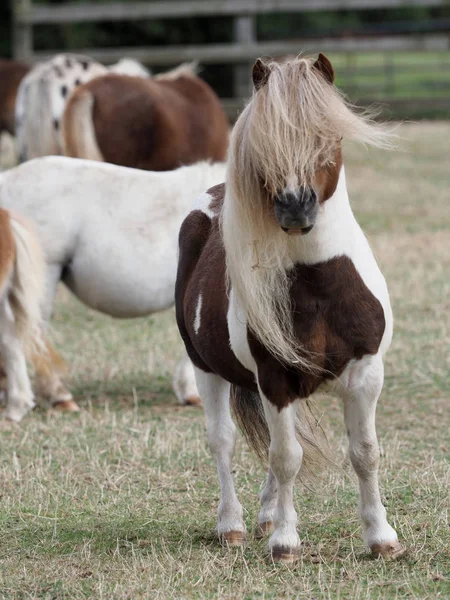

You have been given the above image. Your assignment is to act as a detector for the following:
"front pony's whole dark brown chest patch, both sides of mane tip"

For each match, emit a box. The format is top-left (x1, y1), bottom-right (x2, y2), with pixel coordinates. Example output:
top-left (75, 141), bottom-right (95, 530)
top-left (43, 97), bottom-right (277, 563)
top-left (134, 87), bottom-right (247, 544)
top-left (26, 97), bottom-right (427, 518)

top-left (248, 256), bottom-right (385, 410)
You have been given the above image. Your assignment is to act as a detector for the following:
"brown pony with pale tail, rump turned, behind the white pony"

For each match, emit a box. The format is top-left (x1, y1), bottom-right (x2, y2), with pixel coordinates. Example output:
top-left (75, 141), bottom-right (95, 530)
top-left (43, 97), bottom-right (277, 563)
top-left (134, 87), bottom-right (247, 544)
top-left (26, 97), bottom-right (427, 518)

top-left (62, 65), bottom-right (229, 171)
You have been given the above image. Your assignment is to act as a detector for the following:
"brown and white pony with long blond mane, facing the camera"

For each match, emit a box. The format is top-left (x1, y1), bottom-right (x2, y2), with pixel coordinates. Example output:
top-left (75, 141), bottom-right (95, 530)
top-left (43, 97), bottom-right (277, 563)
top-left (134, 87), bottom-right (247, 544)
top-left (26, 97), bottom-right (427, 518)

top-left (175, 54), bottom-right (403, 561)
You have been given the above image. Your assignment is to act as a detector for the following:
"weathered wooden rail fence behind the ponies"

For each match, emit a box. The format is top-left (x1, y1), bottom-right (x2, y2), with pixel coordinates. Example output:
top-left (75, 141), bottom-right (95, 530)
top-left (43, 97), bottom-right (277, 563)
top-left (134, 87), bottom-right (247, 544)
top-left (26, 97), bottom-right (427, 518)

top-left (11, 0), bottom-right (450, 113)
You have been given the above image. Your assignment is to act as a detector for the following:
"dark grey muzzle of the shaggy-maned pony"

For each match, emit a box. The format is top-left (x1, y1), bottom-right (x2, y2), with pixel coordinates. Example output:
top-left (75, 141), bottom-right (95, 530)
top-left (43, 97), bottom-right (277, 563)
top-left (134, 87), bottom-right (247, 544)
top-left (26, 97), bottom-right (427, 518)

top-left (274, 187), bottom-right (319, 234)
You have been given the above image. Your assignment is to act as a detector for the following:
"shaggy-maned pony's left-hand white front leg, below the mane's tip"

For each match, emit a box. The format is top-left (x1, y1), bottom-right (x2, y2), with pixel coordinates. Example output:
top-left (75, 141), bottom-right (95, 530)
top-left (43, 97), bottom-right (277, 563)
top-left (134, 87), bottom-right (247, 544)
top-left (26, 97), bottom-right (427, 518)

top-left (261, 394), bottom-right (303, 562)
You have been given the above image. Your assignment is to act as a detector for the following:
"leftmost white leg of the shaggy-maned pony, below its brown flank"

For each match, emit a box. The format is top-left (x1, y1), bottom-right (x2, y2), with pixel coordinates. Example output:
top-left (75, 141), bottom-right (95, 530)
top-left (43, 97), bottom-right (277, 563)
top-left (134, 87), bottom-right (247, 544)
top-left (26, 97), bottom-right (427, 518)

top-left (195, 368), bottom-right (245, 546)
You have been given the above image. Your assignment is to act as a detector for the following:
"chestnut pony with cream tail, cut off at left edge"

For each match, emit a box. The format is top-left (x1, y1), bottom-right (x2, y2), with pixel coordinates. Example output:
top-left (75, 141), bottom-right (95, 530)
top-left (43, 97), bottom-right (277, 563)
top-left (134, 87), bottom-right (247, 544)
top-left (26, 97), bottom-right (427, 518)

top-left (0, 209), bottom-right (45, 421)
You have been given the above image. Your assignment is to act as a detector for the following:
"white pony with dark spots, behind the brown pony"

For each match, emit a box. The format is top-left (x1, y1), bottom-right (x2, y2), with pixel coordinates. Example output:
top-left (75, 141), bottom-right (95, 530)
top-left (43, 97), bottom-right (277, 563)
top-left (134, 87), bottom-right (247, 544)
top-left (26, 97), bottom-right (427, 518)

top-left (16, 54), bottom-right (150, 162)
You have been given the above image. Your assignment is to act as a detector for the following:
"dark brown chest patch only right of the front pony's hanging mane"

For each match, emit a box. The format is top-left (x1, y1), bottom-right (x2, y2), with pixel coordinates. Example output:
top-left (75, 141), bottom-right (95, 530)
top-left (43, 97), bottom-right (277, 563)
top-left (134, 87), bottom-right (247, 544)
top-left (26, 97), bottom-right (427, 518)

top-left (290, 256), bottom-right (385, 375)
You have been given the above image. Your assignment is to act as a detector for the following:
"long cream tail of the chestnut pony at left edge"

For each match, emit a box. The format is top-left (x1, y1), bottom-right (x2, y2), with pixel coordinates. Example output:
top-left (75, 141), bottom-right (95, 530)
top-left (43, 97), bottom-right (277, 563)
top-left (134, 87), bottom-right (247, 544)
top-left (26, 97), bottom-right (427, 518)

top-left (9, 213), bottom-right (45, 357)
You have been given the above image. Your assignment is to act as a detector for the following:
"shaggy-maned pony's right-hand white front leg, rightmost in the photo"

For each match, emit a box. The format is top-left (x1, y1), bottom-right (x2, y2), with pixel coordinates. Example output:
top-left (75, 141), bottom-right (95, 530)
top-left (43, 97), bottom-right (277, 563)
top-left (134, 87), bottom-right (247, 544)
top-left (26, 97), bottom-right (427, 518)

top-left (341, 355), bottom-right (404, 558)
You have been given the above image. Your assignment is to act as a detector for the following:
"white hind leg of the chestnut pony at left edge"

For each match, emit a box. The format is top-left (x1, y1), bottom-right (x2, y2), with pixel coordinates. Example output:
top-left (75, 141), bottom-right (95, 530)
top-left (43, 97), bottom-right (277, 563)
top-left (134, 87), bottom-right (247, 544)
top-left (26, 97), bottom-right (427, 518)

top-left (0, 297), bottom-right (34, 422)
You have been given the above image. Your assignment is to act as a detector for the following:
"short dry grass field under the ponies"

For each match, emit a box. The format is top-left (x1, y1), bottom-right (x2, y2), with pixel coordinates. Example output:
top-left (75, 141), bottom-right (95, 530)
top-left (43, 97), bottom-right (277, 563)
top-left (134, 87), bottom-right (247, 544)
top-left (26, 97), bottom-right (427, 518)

top-left (0, 122), bottom-right (450, 600)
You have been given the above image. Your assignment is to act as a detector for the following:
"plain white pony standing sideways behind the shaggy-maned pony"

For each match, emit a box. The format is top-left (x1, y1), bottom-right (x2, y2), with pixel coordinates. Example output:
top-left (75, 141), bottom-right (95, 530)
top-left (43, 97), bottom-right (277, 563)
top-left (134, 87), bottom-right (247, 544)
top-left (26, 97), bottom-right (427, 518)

top-left (0, 156), bottom-right (225, 414)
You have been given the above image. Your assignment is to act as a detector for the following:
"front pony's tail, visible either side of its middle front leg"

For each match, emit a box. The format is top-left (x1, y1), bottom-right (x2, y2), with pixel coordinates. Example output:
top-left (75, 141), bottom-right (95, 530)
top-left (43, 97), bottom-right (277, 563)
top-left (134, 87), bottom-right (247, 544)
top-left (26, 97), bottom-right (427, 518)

top-left (230, 385), bottom-right (333, 480)
